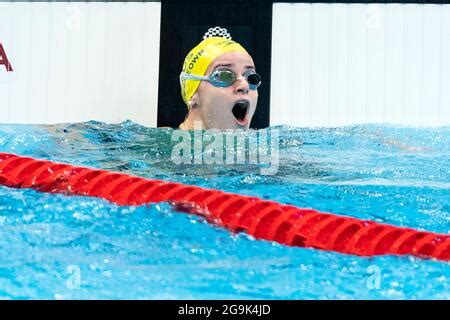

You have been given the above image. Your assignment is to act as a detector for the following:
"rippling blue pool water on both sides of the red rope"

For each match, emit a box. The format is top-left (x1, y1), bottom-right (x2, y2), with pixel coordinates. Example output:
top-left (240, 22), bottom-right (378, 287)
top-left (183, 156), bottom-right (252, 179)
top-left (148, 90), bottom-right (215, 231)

top-left (0, 121), bottom-right (450, 299)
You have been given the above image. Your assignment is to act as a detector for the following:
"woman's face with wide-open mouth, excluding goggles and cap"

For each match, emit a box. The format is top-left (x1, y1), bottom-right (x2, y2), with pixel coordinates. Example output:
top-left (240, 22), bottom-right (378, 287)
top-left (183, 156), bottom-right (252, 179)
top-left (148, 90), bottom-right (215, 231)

top-left (193, 51), bottom-right (258, 130)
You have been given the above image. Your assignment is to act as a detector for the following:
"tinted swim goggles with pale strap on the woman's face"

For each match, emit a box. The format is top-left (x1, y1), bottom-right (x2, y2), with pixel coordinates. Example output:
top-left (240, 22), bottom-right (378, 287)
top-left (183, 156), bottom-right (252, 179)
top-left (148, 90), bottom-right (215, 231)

top-left (180, 68), bottom-right (261, 90)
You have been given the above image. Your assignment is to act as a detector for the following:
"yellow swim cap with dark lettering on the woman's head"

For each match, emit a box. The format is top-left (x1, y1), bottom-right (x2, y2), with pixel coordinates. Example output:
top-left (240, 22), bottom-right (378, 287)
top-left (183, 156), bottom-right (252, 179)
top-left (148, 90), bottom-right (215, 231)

top-left (180, 37), bottom-right (247, 110)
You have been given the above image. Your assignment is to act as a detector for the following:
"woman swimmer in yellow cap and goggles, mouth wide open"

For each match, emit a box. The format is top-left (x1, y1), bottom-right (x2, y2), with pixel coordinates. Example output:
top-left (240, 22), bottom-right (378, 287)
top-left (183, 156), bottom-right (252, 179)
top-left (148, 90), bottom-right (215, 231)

top-left (180, 27), bottom-right (261, 131)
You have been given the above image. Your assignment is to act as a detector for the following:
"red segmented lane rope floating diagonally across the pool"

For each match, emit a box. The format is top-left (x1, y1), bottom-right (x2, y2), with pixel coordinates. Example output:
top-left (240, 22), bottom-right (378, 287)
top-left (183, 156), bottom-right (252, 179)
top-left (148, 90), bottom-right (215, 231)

top-left (0, 153), bottom-right (450, 261)
